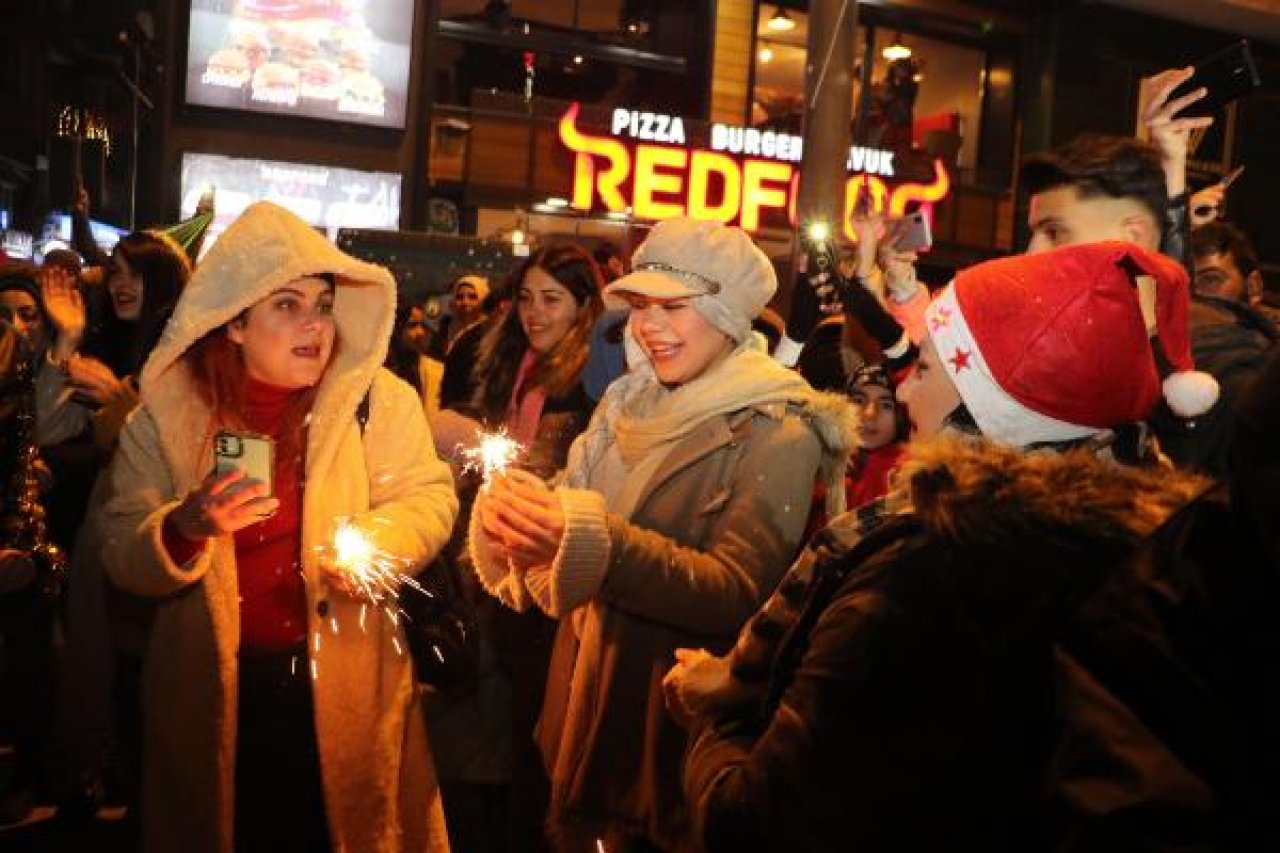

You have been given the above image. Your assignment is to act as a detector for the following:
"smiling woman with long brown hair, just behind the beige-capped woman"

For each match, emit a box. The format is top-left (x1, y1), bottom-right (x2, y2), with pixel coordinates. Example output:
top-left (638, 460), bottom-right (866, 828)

top-left (430, 239), bottom-right (603, 849)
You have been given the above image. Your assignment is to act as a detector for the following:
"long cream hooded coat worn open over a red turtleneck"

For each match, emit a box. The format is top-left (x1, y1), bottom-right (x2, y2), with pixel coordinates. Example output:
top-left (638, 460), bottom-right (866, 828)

top-left (99, 202), bottom-right (457, 853)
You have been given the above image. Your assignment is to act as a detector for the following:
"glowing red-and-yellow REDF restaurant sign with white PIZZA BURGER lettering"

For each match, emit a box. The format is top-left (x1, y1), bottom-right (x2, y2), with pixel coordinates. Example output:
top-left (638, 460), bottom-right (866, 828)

top-left (559, 104), bottom-right (951, 241)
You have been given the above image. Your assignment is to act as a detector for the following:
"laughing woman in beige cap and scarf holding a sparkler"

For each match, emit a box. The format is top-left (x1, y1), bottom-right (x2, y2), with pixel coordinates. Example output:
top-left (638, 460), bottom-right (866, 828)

top-left (470, 219), bottom-right (851, 850)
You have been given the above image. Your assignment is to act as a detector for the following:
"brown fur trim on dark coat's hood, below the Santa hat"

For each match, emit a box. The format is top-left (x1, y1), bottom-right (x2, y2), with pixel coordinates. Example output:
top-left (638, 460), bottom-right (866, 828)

top-left (895, 438), bottom-right (1210, 547)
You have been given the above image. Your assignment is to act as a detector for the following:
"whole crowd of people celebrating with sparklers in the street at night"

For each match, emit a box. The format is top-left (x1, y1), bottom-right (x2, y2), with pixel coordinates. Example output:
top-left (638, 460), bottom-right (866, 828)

top-left (0, 61), bottom-right (1280, 853)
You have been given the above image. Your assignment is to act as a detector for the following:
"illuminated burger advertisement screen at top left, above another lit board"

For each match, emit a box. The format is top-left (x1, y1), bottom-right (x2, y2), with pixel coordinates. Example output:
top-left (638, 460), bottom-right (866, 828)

top-left (187, 0), bottom-right (413, 128)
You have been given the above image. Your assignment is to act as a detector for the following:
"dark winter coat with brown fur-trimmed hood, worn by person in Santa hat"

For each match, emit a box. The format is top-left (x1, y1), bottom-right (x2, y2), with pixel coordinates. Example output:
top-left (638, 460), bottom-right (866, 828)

top-left (685, 444), bottom-right (1275, 853)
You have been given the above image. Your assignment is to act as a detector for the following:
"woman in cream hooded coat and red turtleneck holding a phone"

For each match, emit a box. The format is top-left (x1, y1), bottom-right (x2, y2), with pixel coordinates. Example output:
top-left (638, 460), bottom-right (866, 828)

top-left (93, 202), bottom-right (457, 852)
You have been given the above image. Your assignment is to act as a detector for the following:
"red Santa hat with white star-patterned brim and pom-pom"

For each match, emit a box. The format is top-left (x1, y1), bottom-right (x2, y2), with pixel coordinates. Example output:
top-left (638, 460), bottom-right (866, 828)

top-left (925, 242), bottom-right (1219, 446)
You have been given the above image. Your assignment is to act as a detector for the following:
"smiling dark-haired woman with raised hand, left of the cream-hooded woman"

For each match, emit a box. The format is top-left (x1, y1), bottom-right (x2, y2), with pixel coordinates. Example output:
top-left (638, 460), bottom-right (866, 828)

top-left (37, 231), bottom-right (191, 812)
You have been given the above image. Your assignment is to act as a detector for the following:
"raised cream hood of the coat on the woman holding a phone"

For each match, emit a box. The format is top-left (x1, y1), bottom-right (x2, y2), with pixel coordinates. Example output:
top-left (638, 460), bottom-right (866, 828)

top-left (141, 201), bottom-right (396, 479)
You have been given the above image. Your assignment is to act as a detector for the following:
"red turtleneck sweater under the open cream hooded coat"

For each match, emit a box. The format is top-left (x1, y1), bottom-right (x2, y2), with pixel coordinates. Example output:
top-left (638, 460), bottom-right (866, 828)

top-left (164, 379), bottom-right (307, 657)
